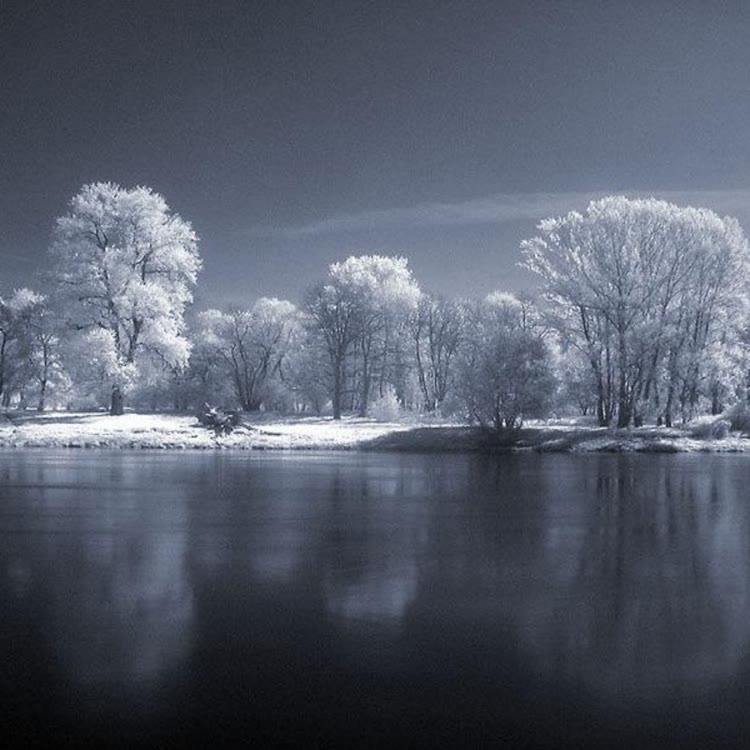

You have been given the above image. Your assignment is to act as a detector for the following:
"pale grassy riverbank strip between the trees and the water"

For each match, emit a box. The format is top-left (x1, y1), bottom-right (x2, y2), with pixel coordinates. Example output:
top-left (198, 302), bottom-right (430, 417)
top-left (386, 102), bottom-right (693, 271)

top-left (0, 411), bottom-right (750, 453)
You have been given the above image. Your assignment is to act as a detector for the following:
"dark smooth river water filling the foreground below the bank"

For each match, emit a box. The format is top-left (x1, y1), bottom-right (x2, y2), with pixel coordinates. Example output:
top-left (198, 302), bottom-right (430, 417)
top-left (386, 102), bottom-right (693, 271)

top-left (0, 451), bottom-right (750, 747)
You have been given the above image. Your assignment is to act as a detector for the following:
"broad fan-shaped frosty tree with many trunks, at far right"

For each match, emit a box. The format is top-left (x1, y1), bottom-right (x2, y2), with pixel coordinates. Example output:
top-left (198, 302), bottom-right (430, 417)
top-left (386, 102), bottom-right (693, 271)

top-left (522, 197), bottom-right (750, 427)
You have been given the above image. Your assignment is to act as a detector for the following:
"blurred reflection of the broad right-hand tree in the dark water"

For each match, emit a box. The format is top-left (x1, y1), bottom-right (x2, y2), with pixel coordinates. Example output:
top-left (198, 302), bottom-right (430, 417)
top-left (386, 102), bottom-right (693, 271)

top-left (506, 456), bottom-right (750, 697)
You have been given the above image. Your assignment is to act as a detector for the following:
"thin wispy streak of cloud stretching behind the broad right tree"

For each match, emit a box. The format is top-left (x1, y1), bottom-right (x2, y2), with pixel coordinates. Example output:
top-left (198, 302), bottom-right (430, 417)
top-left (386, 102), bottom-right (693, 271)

top-left (253, 189), bottom-right (750, 239)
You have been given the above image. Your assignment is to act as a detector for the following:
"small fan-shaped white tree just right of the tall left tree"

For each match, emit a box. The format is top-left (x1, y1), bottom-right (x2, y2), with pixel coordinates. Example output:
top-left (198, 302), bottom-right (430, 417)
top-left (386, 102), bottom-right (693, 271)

top-left (198, 297), bottom-right (299, 411)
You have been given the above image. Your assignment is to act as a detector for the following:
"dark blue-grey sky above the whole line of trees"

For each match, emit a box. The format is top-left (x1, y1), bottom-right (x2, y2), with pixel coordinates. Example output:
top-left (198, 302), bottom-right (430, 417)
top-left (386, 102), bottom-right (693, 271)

top-left (0, 0), bottom-right (750, 305)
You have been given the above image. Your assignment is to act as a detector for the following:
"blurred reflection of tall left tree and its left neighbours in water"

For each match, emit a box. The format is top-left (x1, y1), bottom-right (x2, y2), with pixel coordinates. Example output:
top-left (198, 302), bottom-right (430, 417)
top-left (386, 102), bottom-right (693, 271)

top-left (0, 456), bottom-right (197, 720)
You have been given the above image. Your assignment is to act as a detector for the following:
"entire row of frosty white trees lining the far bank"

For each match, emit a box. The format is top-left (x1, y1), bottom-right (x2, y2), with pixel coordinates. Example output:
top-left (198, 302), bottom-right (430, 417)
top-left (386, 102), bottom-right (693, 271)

top-left (0, 183), bottom-right (750, 429)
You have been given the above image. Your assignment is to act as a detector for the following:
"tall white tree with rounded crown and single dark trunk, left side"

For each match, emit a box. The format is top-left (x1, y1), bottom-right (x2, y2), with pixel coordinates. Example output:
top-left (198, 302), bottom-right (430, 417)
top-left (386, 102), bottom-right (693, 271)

top-left (51, 182), bottom-right (201, 414)
